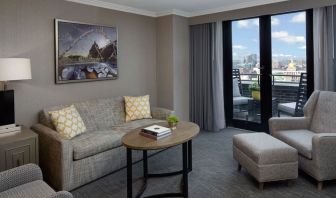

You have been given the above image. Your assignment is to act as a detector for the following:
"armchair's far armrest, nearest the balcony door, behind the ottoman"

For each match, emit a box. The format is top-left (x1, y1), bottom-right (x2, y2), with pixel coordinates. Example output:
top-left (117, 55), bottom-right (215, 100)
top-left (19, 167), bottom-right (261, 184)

top-left (268, 117), bottom-right (309, 135)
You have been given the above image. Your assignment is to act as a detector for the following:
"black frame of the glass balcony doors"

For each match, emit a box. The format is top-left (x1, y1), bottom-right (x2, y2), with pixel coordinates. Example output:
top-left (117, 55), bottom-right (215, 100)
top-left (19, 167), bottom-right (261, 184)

top-left (223, 9), bottom-right (314, 132)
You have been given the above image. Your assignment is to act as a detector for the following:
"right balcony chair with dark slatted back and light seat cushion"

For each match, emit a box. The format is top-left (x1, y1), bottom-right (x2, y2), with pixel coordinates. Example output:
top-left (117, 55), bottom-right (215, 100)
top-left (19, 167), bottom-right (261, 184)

top-left (278, 73), bottom-right (307, 117)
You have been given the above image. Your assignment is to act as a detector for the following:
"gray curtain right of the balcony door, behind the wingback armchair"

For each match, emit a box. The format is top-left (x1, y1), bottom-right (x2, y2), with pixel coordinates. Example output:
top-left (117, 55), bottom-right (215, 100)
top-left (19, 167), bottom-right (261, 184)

top-left (314, 6), bottom-right (336, 91)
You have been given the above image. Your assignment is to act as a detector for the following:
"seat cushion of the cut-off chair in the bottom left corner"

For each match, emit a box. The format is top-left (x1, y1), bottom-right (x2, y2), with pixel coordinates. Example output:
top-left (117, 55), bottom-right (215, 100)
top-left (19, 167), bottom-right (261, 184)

top-left (0, 180), bottom-right (55, 198)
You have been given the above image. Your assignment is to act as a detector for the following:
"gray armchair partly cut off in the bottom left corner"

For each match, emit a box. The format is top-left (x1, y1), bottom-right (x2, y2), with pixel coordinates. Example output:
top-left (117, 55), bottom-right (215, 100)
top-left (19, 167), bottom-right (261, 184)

top-left (0, 164), bottom-right (72, 198)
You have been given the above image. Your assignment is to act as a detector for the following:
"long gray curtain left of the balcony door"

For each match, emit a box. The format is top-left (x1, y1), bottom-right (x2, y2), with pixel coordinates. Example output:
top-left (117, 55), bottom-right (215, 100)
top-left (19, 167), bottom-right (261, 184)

top-left (190, 22), bottom-right (225, 131)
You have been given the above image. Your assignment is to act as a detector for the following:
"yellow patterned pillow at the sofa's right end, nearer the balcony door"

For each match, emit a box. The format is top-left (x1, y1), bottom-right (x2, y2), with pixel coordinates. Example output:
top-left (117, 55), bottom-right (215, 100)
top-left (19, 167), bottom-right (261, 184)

top-left (124, 95), bottom-right (152, 122)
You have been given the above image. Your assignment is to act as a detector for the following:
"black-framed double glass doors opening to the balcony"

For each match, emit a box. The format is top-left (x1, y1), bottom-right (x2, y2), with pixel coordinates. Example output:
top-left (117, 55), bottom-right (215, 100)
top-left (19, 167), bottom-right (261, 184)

top-left (223, 11), bottom-right (313, 131)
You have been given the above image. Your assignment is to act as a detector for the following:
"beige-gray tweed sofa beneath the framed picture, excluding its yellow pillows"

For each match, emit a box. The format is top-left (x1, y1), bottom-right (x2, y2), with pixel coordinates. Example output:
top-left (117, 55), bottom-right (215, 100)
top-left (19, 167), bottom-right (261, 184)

top-left (32, 97), bottom-right (172, 191)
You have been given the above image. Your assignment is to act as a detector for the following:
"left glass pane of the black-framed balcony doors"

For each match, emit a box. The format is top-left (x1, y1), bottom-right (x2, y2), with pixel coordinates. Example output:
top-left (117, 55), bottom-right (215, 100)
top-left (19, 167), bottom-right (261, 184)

top-left (232, 18), bottom-right (260, 123)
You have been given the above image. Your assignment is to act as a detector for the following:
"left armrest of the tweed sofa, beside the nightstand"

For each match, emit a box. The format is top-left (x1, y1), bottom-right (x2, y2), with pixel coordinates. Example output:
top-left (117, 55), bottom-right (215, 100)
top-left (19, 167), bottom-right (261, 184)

top-left (32, 124), bottom-right (73, 190)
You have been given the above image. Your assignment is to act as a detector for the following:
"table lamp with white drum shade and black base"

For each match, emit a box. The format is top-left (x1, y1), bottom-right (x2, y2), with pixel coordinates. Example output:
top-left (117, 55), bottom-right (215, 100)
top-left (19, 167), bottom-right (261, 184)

top-left (0, 58), bottom-right (31, 129)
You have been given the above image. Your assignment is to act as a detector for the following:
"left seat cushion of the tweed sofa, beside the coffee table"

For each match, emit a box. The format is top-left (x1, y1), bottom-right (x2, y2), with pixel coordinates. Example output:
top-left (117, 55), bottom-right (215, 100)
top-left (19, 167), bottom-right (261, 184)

top-left (71, 130), bottom-right (126, 160)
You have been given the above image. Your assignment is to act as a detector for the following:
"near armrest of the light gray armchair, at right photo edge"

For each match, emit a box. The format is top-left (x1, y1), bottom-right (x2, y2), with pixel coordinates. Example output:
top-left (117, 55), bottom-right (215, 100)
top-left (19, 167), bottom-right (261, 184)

top-left (312, 133), bottom-right (336, 168)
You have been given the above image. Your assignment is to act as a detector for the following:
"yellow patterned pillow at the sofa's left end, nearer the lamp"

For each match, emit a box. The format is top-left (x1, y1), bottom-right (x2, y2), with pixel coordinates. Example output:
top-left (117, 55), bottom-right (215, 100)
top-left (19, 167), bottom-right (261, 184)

top-left (49, 105), bottom-right (86, 139)
